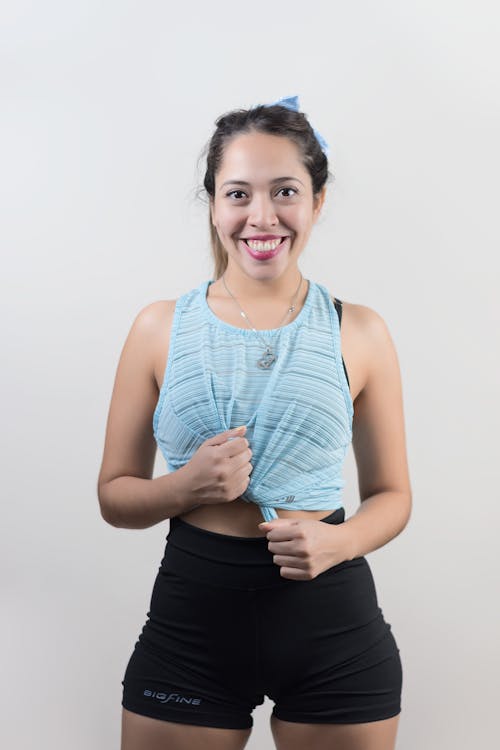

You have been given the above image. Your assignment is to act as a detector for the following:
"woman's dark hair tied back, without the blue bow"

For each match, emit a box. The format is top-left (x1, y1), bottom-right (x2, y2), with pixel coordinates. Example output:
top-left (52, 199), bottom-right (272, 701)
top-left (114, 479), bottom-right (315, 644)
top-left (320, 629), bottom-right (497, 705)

top-left (200, 104), bottom-right (330, 280)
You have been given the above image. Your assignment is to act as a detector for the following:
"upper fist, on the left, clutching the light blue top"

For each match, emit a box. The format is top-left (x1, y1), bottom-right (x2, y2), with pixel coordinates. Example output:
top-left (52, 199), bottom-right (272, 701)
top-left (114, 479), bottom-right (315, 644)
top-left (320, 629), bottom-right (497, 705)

top-left (178, 425), bottom-right (253, 505)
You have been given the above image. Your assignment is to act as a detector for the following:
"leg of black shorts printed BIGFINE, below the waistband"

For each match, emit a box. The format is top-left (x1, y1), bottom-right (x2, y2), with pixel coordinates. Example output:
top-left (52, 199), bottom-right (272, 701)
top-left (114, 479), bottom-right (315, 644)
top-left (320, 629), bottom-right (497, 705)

top-left (122, 568), bottom-right (264, 730)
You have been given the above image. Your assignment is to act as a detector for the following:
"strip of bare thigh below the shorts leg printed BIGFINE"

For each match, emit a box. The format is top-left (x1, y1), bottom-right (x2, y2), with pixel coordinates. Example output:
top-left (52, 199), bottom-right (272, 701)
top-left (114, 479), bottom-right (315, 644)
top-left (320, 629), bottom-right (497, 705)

top-left (120, 708), bottom-right (252, 750)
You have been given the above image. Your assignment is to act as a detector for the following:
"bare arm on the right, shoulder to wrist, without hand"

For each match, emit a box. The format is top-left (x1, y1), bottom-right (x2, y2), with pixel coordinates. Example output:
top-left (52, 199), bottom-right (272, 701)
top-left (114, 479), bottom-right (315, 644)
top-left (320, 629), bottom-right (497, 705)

top-left (339, 307), bottom-right (412, 559)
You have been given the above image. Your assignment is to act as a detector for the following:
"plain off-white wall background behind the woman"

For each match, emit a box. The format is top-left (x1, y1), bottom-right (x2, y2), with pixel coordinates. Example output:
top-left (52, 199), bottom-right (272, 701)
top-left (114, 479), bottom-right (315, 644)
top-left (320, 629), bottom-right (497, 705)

top-left (0, 0), bottom-right (500, 750)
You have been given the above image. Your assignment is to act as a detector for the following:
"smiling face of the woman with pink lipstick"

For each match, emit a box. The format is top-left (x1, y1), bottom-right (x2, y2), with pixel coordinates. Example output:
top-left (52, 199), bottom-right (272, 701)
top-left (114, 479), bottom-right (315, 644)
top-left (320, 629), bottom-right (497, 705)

top-left (210, 132), bottom-right (326, 279)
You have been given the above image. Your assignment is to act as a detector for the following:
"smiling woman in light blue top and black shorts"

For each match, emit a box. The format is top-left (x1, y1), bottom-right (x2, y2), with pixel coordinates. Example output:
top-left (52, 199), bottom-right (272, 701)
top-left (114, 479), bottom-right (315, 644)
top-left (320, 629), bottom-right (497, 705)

top-left (98, 97), bottom-right (411, 750)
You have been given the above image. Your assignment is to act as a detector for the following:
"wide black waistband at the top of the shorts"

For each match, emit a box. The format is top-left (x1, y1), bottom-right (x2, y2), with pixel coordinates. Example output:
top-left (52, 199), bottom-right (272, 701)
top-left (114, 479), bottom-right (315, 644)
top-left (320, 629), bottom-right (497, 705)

top-left (161, 507), bottom-right (345, 588)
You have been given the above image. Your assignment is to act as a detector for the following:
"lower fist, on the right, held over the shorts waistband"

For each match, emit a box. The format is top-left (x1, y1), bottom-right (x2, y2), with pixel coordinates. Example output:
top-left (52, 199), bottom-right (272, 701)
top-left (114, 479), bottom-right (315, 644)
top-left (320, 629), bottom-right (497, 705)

top-left (259, 518), bottom-right (352, 581)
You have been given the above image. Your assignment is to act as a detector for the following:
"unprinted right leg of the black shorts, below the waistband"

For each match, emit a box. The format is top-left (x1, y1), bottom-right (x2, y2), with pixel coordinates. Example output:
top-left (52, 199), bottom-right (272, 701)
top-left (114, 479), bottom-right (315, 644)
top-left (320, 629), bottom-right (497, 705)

top-left (259, 557), bottom-right (402, 731)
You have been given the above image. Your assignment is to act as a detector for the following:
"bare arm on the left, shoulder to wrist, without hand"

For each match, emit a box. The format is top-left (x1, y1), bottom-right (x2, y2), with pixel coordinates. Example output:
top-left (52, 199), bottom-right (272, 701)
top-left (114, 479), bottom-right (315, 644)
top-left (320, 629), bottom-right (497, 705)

top-left (97, 300), bottom-right (200, 529)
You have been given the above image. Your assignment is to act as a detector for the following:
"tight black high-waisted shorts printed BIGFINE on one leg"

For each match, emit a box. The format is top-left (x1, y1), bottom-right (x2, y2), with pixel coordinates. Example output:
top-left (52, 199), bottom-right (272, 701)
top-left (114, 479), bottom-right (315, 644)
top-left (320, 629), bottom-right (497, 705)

top-left (122, 508), bottom-right (402, 729)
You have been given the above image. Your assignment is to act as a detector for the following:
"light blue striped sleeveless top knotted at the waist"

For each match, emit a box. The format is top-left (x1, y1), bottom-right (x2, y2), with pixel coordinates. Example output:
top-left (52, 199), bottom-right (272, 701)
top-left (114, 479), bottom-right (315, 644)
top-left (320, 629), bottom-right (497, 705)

top-left (153, 280), bottom-right (354, 521)
